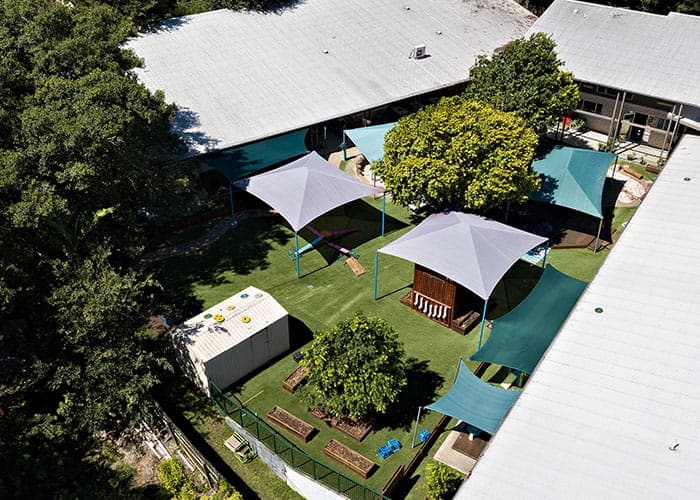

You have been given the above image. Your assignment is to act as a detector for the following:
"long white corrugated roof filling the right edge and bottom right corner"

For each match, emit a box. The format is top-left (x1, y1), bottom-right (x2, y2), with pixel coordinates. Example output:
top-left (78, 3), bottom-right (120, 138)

top-left (456, 132), bottom-right (700, 499)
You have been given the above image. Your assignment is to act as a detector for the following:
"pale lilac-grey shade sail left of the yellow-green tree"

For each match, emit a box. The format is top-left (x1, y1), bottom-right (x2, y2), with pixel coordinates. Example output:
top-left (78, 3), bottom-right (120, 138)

top-left (234, 151), bottom-right (384, 231)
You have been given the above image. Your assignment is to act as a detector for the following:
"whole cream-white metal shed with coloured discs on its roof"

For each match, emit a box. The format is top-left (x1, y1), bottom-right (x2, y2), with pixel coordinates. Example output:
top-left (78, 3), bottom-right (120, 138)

top-left (172, 286), bottom-right (289, 396)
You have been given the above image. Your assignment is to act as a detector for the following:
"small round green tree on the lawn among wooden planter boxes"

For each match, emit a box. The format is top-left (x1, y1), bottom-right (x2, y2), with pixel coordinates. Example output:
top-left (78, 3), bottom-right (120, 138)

top-left (301, 313), bottom-right (406, 420)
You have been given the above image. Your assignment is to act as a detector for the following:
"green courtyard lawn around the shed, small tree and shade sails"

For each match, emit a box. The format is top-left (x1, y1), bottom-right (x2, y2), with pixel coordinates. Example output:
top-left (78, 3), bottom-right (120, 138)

top-left (157, 200), bottom-right (628, 498)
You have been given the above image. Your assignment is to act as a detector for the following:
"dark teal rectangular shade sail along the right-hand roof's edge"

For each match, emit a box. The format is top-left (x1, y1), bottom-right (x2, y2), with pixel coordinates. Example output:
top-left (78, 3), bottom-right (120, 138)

top-left (469, 266), bottom-right (587, 373)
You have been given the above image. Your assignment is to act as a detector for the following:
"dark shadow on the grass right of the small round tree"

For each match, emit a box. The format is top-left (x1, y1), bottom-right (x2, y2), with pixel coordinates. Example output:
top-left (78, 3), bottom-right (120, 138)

top-left (376, 358), bottom-right (445, 430)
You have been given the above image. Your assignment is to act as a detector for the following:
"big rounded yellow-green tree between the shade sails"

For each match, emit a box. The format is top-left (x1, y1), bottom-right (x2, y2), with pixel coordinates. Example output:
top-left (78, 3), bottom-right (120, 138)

top-left (373, 97), bottom-right (539, 210)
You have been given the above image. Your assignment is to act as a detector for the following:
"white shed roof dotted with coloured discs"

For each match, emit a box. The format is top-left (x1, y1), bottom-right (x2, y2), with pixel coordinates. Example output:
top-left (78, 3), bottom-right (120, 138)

top-left (172, 286), bottom-right (287, 362)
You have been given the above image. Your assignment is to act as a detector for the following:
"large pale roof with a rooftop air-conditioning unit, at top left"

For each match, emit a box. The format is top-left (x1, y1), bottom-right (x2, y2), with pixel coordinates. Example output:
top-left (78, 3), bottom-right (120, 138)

top-left (127, 0), bottom-right (535, 152)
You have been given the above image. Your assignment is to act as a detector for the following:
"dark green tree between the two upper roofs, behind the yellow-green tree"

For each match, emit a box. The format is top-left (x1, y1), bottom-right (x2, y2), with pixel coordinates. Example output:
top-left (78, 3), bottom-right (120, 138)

top-left (464, 33), bottom-right (579, 134)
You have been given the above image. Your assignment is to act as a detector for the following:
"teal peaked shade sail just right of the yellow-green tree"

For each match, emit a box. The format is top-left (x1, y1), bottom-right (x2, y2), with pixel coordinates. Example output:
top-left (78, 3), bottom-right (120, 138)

top-left (530, 146), bottom-right (615, 219)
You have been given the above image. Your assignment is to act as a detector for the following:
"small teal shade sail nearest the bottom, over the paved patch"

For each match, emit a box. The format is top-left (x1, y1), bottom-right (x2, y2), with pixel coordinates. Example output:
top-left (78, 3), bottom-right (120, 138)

top-left (426, 360), bottom-right (520, 434)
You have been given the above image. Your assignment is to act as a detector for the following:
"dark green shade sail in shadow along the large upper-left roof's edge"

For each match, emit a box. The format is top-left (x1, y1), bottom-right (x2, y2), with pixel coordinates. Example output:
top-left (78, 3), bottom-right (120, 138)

top-left (200, 128), bottom-right (308, 182)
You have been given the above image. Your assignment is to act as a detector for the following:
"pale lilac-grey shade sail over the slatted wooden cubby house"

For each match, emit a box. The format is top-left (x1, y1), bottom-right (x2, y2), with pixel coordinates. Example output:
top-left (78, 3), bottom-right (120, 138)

top-left (379, 212), bottom-right (547, 299)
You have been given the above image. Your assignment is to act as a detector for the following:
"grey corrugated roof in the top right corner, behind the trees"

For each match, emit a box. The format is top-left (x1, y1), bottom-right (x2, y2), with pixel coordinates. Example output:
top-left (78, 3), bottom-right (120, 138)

top-left (528, 0), bottom-right (700, 105)
